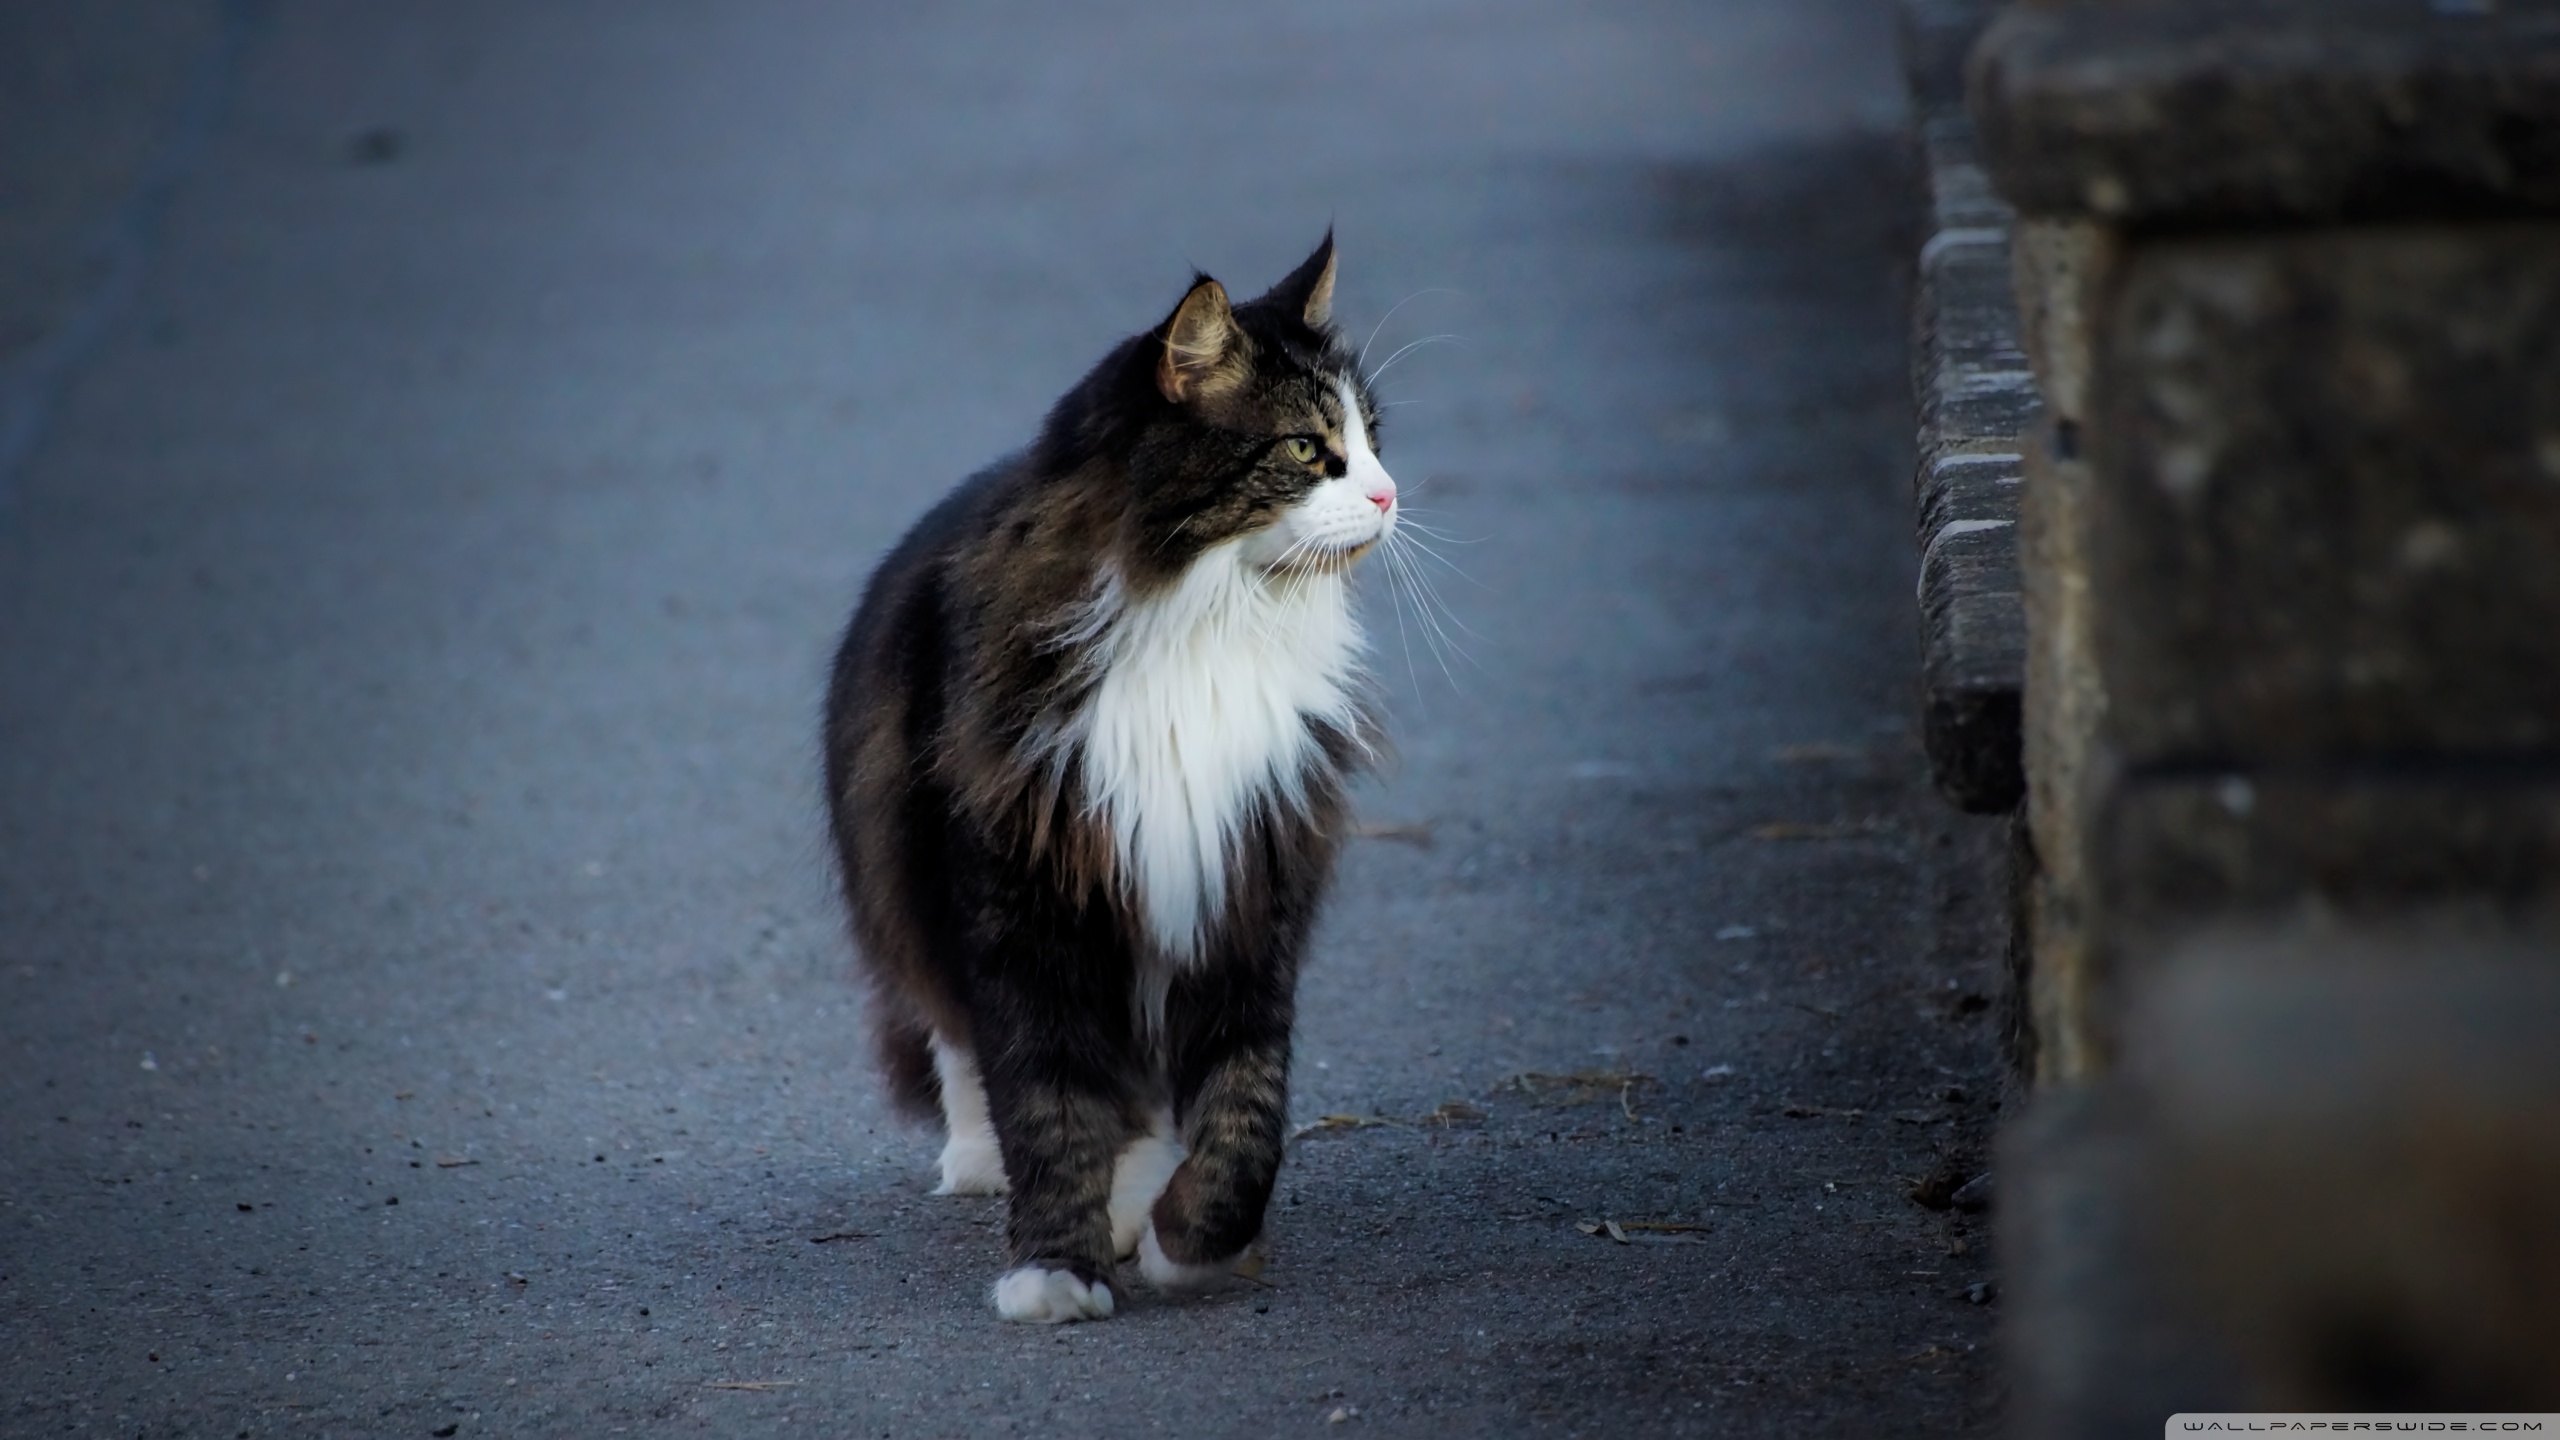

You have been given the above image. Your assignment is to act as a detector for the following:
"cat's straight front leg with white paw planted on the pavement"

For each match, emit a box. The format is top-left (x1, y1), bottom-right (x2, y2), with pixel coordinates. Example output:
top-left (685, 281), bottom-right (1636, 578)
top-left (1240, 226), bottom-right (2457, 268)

top-left (986, 1024), bottom-right (1139, 1325)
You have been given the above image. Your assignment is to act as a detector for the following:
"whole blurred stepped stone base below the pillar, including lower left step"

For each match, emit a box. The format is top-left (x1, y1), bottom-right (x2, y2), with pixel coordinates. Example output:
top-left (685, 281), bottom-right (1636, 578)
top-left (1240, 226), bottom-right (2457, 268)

top-left (1997, 925), bottom-right (2560, 1440)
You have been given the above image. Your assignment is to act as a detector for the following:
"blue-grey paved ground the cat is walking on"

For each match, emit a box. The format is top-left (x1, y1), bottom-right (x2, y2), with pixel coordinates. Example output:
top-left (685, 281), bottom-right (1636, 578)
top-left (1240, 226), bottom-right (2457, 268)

top-left (0, 0), bottom-right (1999, 1437)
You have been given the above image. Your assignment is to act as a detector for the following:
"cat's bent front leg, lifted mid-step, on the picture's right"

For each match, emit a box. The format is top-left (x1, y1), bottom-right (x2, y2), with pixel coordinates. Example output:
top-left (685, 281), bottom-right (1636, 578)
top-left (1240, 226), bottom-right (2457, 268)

top-left (1139, 994), bottom-right (1288, 1291)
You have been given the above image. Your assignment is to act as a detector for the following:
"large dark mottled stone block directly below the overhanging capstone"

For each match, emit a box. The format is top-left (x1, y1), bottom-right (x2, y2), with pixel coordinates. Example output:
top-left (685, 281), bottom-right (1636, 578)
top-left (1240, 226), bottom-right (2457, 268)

top-left (2088, 223), bottom-right (2560, 766)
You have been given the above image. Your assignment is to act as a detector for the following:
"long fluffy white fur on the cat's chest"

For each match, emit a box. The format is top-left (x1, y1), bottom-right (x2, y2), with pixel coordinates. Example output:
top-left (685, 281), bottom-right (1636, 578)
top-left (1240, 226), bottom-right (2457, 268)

top-left (1073, 543), bottom-right (1362, 963)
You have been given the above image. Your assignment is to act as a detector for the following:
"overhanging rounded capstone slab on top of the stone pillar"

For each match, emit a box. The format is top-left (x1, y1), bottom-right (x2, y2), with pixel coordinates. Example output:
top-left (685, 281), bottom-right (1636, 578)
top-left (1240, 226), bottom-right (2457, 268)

top-left (1969, 0), bottom-right (2560, 225)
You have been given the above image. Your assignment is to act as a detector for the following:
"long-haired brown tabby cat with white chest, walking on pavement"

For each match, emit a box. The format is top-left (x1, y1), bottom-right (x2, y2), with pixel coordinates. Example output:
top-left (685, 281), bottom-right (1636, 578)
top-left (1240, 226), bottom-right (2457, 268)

top-left (824, 236), bottom-right (1395, 1322)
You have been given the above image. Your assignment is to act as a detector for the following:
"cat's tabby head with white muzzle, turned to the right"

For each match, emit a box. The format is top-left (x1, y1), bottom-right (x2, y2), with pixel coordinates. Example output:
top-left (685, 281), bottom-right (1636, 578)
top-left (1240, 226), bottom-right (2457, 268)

top-left (1080, 236), bottom-right (1395, 574)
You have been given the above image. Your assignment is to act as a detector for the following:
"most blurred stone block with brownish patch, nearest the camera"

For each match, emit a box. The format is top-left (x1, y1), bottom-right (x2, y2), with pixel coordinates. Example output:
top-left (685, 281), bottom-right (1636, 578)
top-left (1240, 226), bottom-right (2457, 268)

top-left (2125, 925), bottom-right (2560, 1409)
